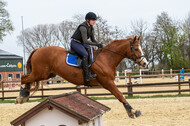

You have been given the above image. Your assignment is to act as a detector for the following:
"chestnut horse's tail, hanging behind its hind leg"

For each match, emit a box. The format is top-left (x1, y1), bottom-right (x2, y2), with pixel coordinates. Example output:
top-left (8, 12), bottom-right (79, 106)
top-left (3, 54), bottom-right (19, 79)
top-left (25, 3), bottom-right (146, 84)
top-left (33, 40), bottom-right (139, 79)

top-left (26, 49), bottom-right (39, 96)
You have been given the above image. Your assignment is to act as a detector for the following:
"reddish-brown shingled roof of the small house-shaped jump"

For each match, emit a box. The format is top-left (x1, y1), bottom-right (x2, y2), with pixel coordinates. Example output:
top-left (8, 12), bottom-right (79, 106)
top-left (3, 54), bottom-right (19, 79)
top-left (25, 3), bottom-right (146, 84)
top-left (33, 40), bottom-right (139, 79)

top-left (11, 91), bottom-right (110, 126)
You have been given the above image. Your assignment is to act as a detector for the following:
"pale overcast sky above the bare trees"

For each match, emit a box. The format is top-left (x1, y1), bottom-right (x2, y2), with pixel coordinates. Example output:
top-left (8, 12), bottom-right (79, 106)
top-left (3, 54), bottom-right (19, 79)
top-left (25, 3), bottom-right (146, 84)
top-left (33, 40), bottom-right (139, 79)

top-left (0, 0), bottom-right (190, 59)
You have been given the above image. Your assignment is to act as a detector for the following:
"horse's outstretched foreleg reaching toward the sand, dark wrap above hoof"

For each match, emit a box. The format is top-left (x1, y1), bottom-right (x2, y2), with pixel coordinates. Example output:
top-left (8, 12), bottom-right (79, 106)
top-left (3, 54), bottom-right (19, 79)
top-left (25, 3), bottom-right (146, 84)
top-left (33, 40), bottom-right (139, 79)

top-left (103, 81), bottom-right (141, 118)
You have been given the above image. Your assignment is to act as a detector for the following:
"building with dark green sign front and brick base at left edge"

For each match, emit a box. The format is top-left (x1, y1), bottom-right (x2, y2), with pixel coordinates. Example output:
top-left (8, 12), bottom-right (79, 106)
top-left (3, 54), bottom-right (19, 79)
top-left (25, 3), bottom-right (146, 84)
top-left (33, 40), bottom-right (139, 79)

top-left (0, 49), bottom-right (23, 81)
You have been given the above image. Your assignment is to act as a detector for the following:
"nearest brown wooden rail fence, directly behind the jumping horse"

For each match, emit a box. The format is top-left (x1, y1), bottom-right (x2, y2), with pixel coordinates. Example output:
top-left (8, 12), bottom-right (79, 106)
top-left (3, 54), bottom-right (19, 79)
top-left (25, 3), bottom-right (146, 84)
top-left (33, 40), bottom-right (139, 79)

top-left (0, 73), bottom-right (190, 100)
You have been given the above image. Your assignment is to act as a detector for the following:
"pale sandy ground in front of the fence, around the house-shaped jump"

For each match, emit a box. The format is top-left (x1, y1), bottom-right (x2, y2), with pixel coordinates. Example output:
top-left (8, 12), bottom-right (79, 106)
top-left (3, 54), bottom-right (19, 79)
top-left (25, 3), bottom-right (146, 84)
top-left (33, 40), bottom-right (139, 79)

top-left (0, 97), bottom-right (190, 126)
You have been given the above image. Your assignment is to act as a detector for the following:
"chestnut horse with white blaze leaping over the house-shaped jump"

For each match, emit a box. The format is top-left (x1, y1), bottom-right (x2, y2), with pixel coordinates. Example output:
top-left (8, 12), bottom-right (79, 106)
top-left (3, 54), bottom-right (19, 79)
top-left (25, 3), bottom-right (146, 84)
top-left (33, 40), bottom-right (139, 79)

top-left (16, 36), bottom-right (147, 118)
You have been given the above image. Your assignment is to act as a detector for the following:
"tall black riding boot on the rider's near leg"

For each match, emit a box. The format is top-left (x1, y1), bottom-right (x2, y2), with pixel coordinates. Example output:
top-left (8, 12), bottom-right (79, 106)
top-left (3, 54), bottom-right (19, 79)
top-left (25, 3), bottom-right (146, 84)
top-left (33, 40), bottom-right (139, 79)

top-left (82, 56), bottom-right (95, 86)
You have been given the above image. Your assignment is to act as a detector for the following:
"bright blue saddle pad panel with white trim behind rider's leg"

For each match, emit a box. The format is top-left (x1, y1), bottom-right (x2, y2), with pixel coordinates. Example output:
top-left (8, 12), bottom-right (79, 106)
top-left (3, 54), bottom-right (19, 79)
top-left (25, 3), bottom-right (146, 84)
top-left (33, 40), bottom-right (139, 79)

top-left (66, 53), bottom-right (79, 67)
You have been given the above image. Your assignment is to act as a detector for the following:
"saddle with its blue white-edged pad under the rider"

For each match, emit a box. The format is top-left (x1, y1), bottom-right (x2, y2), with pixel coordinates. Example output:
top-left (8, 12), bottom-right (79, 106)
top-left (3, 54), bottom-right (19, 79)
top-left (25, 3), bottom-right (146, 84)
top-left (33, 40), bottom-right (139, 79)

top-left (66, 47), bottom-right (94, 68)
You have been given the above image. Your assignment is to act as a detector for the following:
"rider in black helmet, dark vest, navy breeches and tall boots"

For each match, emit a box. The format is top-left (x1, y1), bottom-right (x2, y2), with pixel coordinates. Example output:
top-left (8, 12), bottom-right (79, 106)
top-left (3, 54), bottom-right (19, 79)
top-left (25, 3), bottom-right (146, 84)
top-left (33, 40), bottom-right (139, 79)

top-left (71, 12), bottom-right (102, 86)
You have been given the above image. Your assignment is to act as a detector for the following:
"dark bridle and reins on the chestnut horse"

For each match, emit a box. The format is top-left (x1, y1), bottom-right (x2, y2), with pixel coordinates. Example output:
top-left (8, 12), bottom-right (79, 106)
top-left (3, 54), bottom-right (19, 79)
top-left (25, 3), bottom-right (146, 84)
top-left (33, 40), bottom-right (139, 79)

top-left (94, 40), bottom-right (145, 64)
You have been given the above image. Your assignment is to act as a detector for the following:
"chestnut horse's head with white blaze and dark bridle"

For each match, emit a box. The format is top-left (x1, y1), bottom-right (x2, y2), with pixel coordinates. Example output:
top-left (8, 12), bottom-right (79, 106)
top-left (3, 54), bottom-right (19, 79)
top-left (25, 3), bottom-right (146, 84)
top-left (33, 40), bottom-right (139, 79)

top-left (129, 36), bottom-right (148, 67)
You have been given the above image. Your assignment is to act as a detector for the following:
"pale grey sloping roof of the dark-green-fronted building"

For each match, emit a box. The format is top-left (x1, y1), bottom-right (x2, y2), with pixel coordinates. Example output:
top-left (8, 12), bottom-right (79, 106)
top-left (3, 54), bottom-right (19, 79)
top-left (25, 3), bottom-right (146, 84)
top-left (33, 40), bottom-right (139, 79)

top-left (0, 49), bottom-right (22, 59)
